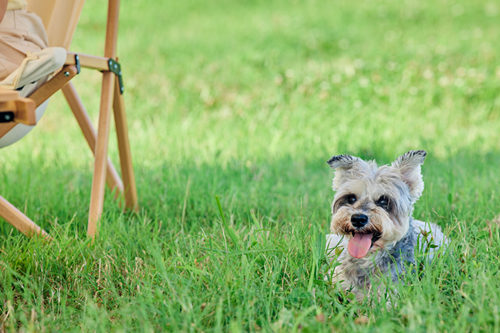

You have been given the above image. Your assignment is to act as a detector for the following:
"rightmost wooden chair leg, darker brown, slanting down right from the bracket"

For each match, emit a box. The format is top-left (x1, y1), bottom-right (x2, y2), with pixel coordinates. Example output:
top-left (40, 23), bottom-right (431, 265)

top-left (113, 77), bottom-right (139, 211)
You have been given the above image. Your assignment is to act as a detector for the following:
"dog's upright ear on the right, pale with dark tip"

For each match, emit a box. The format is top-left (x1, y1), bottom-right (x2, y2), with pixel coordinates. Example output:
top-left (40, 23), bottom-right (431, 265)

top-left (391, 150), bottom-right (427, 202)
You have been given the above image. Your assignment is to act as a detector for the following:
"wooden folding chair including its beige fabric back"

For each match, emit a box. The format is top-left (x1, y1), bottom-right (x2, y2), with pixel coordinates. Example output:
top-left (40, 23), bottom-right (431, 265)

top-left (0, 0), bottom-right (138, 238)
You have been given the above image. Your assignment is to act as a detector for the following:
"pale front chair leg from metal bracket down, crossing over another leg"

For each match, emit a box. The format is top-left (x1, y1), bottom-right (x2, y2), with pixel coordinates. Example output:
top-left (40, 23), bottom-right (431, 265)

top-left (87, 72), bottom-right (115, 238)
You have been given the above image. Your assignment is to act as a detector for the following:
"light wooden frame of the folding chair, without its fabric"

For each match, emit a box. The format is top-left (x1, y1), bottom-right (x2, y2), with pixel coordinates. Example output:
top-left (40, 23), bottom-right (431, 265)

top-left (0, 0), bottom-right (138, 238)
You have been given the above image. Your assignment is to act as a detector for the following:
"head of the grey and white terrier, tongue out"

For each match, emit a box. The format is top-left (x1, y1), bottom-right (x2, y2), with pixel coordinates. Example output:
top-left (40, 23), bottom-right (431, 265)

top-left (328, 150), bottom-right (427, 258)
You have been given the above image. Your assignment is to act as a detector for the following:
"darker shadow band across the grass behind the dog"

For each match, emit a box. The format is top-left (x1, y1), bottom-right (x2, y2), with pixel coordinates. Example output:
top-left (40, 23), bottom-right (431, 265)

top-left (0, 147), bottom-right (500, 235)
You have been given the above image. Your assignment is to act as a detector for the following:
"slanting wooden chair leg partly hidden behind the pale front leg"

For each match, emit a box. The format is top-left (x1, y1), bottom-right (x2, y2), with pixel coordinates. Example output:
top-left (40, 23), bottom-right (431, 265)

top-left (62, 82), bottom-right (123, 199)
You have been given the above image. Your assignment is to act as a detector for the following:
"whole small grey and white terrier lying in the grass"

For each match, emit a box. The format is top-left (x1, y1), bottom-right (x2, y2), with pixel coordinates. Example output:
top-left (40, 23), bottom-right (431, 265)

top-left (327, 150), bottom-right (447, 299)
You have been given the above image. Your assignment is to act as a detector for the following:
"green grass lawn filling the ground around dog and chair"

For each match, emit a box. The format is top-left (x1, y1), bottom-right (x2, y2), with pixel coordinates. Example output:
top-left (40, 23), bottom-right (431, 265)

top-left (0, 0), bottom-right (500, 332)
